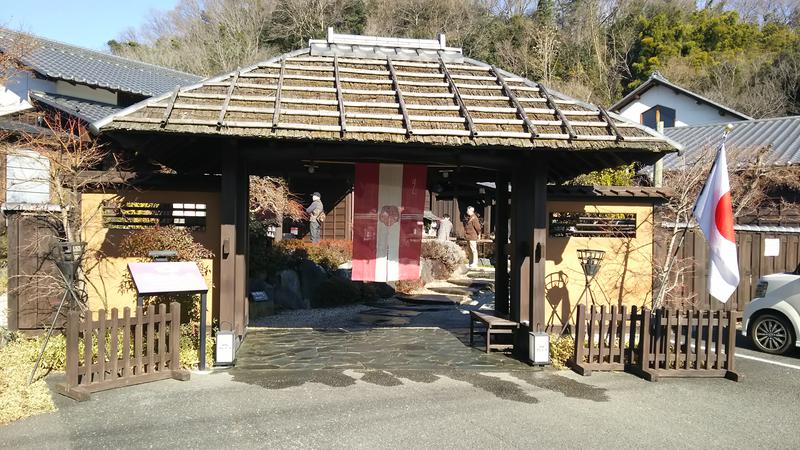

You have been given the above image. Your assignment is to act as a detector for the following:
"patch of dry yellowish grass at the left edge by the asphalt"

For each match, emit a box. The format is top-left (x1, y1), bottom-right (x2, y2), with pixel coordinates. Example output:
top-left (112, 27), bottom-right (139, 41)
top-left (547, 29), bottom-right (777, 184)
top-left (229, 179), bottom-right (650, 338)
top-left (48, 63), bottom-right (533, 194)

top-left (0, 335), bottom-right (65, 425)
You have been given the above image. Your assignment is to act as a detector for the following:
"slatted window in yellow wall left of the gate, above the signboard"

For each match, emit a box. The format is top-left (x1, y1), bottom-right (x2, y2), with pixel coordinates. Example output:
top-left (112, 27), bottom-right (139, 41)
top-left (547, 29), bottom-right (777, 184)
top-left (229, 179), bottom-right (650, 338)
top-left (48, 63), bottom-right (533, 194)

top-left (103, 201), bottom-right (206, 231)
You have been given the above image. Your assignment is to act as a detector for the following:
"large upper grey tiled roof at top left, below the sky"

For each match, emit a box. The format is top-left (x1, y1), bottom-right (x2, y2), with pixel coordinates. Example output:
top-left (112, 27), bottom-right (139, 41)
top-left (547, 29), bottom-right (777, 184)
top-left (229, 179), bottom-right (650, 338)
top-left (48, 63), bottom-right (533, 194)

top-left (0, 28), bottom-right (202, 96)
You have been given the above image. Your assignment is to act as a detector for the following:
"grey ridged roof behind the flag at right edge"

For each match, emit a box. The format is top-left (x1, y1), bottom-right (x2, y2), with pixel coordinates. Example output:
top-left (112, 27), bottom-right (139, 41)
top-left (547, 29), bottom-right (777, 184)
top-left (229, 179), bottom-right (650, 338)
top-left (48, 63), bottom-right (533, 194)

top-left (664, 116), bottom-right (800, 170)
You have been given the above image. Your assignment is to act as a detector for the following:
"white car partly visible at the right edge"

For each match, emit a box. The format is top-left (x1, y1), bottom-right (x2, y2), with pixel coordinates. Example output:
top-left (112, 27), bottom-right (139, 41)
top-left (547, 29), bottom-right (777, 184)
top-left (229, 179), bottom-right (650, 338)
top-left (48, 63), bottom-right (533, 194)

top-left (742, 265), bottom-right (800, 355)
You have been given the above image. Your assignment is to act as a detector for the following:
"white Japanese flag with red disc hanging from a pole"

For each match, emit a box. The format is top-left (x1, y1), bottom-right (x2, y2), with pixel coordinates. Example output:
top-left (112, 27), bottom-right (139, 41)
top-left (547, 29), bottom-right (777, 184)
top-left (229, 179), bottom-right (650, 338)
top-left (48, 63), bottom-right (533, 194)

top-left (693, 143), bottom-right (739, 303)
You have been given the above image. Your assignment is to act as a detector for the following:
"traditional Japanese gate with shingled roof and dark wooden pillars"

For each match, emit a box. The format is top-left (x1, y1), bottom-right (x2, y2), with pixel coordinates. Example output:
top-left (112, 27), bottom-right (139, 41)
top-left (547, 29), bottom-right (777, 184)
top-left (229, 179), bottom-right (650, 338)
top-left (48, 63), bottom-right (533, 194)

top-left (93, 30), bottom-right (675, 356)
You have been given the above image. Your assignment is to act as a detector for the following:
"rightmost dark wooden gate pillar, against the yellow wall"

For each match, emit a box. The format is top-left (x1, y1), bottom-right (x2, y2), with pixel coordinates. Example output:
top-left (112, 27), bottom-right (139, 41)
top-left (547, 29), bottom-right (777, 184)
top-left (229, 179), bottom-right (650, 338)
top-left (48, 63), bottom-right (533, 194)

top-left (530, 161), bottom-right (547, 331)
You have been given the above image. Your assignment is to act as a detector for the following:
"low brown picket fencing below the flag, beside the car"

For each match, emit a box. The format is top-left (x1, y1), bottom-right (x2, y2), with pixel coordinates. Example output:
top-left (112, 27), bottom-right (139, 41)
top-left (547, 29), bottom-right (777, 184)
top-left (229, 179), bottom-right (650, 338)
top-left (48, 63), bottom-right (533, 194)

top-left (570, 305), bottom-right (739, 381)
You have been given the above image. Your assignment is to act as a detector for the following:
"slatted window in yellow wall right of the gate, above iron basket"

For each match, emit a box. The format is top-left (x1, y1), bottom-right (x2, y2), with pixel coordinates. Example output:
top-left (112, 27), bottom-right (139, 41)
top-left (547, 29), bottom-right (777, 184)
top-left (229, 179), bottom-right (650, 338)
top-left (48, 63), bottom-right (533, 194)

top-left (550, 212), bottom-right (636, 238)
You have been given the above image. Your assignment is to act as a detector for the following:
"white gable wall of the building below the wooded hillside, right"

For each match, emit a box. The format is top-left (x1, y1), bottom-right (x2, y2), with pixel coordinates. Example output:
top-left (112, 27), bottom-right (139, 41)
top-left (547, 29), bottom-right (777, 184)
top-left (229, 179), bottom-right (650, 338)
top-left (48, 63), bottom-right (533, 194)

top-left (620, 85), bottom-right (741, 127)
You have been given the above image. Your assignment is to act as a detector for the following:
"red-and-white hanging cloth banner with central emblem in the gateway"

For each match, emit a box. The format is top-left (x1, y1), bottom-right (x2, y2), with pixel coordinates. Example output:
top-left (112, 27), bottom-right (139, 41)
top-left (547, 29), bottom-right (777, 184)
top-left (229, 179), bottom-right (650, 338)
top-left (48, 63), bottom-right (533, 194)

top-left (353, 163), bottom-right (427, 281)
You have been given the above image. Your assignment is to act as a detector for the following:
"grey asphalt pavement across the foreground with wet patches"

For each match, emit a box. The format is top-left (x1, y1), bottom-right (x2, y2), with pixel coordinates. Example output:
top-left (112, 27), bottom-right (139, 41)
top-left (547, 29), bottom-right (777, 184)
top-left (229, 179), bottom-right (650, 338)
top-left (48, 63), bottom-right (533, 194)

top-left (0, 342), bottom-right (800, 449)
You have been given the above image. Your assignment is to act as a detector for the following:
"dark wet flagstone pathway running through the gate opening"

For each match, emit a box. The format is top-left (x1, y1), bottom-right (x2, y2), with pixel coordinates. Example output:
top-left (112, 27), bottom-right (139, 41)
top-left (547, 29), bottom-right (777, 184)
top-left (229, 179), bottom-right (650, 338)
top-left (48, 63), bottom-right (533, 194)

top-left (232, 272), bottom-right (529, 374)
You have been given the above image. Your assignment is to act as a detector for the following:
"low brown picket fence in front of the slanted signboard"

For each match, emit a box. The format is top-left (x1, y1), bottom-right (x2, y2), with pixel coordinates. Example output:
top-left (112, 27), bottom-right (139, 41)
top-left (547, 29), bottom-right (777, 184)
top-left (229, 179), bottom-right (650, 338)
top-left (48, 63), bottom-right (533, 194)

top-left (57, 303), bottom-right (189, 401)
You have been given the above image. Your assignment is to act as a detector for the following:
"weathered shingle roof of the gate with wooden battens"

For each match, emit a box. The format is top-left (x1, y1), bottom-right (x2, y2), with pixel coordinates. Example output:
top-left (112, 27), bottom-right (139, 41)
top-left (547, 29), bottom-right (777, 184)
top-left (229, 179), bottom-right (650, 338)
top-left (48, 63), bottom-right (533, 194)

top-left (93, 32), bottom-right (676, 152)
